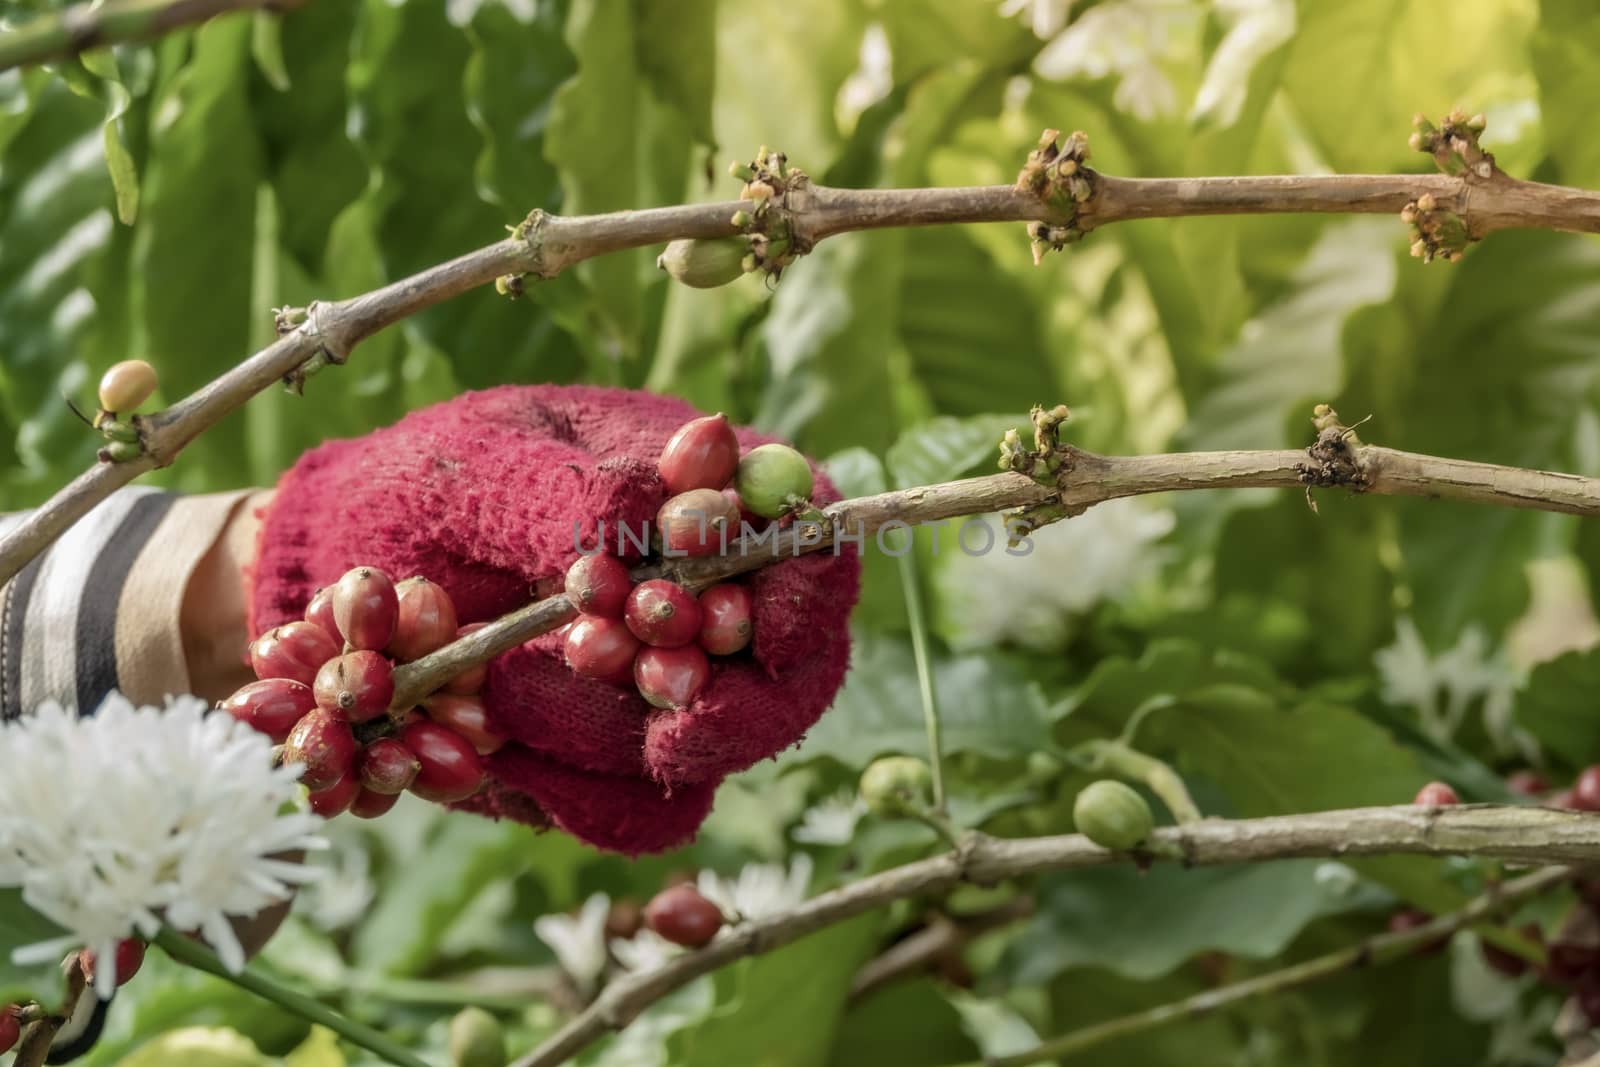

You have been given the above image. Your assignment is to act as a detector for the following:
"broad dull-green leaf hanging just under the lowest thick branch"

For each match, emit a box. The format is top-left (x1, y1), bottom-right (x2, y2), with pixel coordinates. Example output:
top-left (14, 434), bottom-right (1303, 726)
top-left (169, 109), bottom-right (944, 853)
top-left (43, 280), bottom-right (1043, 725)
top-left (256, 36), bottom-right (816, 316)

top-left (1006, 859), bottom-right (1389, 984)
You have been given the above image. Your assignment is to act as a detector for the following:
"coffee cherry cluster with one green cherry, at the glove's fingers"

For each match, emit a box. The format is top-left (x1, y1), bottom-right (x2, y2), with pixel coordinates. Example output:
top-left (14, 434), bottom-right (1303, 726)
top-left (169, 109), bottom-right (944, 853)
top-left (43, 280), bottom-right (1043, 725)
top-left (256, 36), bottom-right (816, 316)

top-left (566, 414), bottom-right (811, 709)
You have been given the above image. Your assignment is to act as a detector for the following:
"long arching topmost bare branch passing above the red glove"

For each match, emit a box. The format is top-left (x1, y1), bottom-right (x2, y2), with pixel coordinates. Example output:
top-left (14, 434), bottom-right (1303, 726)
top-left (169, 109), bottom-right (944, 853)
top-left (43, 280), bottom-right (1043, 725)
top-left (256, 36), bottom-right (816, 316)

top-left (9, 137), bottom-right (1600, 584)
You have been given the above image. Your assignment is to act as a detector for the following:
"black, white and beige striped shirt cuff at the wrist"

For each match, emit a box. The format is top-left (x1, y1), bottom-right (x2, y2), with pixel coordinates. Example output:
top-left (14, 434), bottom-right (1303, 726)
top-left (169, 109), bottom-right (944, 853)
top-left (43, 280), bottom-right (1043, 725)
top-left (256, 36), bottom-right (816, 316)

top-left (0, 486), bottom-right (250, 718)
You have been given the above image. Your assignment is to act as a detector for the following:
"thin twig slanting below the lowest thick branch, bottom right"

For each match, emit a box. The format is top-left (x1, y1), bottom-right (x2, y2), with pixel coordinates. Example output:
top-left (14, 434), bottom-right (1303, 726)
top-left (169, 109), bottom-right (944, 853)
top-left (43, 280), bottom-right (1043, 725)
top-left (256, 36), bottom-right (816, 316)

top-left (965, 867), bottom-right (1571, 1067)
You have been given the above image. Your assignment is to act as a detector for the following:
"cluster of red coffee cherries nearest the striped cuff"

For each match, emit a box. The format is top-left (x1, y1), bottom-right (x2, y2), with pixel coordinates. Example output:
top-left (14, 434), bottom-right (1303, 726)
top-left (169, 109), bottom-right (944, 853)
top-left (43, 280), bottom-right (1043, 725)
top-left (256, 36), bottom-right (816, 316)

top-left (221, 566), bottom-right (506, 819)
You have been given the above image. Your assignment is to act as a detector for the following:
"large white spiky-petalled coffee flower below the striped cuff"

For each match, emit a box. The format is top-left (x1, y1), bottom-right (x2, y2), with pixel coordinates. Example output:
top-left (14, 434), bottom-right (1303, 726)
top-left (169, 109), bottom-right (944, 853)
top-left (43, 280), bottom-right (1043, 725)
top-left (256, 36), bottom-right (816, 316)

top-left (0, 693), bottom-right (323, 997)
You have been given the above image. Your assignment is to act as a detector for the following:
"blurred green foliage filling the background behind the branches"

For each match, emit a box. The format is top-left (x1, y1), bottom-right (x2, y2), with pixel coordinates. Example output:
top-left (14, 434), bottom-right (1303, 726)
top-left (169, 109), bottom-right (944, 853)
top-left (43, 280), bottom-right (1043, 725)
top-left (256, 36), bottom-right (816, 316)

top-left (0, 0), bottom-right (1600, 1067)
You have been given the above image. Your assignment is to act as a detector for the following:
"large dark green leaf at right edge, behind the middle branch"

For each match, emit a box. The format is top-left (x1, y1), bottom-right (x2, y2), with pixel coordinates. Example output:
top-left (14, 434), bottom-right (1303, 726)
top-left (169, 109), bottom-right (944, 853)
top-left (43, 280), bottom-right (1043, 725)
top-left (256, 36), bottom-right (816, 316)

top-left (1338, 232), bottom-right (1600, 646)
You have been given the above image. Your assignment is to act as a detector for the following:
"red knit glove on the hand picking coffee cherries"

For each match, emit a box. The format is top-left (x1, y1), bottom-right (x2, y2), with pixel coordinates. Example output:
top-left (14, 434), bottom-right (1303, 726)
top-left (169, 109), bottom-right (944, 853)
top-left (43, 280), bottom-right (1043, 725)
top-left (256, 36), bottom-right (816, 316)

top-left (250, 386), bottom-right (861, 853)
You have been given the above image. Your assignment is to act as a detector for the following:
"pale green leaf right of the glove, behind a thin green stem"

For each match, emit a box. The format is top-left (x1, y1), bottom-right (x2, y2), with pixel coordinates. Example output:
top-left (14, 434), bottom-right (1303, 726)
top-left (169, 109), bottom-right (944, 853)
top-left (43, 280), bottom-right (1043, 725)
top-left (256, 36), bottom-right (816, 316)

top-left (779, 630), bottom-right (1048, 771)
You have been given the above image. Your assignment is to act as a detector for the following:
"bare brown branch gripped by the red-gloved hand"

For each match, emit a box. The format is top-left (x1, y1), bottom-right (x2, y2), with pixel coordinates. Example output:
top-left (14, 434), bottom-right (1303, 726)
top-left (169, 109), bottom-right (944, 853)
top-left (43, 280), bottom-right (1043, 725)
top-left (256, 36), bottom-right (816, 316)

top-left (394, 434), bottom-right (1600, 710)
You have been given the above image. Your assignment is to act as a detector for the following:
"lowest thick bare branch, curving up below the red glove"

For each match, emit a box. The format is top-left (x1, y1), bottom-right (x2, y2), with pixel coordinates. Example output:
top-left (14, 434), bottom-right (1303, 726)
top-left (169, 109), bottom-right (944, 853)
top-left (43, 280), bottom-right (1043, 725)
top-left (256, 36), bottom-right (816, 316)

top-left (514, 805), bottom-right (1600, 1067)
